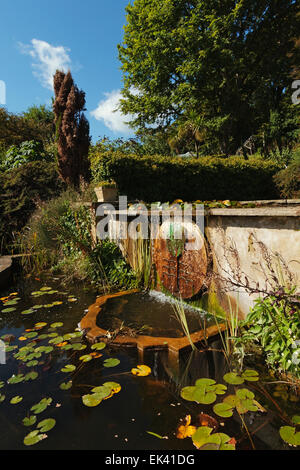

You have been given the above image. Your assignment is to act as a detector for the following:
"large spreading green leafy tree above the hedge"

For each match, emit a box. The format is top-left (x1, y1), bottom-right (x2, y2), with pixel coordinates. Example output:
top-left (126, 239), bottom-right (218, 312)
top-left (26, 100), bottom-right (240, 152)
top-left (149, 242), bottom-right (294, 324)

top-left (119, 0), bottom-right (299, 154)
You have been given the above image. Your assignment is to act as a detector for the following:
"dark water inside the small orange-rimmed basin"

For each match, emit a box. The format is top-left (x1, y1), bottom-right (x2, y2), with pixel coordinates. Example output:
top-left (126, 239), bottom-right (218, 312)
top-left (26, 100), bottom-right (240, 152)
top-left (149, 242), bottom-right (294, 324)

top-left (97, 292), bottom-right (214, 338)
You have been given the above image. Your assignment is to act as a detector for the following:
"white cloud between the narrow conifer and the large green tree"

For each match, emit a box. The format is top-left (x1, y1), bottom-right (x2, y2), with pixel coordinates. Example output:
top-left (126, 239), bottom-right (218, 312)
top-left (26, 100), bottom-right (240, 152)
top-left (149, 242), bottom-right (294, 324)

top-left (91, 90), bottom-right (134, 134)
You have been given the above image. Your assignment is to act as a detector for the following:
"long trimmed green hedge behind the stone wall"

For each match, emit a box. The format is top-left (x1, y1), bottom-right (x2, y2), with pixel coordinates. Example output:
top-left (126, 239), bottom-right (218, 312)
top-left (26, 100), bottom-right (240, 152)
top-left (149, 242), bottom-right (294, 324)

top-left (96, 152), bottom-right (282, 202)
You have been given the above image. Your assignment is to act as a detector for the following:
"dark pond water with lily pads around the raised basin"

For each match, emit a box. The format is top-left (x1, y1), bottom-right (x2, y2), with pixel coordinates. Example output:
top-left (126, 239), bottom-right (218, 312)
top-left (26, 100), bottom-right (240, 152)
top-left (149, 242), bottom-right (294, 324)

top-left (0, 277), bottom-right (299, 450)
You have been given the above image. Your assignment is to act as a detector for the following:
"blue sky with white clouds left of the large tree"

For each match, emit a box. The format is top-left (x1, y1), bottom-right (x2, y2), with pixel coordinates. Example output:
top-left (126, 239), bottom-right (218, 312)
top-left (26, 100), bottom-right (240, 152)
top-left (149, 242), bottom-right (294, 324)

top-left (0, 0), bottom-right (132, 141)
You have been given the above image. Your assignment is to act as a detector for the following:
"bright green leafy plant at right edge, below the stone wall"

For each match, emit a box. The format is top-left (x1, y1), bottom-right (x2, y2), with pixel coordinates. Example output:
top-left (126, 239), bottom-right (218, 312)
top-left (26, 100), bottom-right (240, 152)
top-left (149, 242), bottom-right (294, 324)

top-left (242, 295), bottom-right (300, 378)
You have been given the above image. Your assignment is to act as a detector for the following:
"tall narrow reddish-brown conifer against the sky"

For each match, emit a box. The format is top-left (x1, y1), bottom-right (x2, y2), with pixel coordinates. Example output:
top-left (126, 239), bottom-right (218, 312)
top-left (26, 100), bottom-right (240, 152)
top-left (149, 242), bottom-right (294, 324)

top-left (53, 70), bottom-right (90, 188)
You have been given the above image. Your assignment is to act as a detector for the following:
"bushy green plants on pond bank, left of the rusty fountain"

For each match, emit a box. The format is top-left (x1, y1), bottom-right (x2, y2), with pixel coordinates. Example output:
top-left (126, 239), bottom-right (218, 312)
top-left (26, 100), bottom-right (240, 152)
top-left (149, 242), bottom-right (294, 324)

top-left (19, 190), bottom-right (137, 288)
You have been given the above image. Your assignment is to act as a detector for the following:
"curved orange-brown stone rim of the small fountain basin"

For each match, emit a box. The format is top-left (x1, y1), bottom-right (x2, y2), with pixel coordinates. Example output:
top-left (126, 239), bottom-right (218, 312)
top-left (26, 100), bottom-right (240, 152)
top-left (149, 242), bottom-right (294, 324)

top-left (79, 289), bottom-right (226, 355)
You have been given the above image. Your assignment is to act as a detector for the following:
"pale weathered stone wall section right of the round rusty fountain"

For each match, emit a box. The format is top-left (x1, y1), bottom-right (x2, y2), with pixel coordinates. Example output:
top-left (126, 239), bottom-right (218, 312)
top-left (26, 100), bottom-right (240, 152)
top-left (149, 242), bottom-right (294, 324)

top-left (205, 205), bottom-right (300, 317)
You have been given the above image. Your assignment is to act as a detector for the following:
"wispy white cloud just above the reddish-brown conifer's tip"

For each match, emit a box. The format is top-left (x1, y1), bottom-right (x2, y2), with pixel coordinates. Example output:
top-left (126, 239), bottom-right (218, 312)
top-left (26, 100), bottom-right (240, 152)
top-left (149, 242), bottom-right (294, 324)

top-left (19, 39), bottom-right (72, 90)
